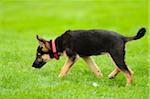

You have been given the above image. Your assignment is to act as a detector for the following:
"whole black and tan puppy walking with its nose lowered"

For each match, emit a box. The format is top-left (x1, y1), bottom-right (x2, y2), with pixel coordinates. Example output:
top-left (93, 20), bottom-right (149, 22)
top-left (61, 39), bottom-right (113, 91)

top-left (33, 28), bottom-right (146, 85)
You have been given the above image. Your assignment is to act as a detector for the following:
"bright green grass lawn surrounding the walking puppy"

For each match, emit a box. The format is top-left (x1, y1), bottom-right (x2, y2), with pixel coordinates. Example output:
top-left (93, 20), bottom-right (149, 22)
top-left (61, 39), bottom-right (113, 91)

top-left (0, 0), bottom-right (149, 99)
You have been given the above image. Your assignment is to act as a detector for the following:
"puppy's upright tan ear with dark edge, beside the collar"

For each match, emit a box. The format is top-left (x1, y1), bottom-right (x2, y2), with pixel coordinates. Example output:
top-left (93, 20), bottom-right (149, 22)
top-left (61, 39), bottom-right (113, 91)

top-left (36, 35), bottom-right (50, 50)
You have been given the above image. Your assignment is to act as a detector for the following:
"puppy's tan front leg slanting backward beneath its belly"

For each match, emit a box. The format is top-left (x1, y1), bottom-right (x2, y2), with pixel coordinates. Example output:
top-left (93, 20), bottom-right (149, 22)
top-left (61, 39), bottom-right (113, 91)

top-left (82, 57), bottom-right (103, 77)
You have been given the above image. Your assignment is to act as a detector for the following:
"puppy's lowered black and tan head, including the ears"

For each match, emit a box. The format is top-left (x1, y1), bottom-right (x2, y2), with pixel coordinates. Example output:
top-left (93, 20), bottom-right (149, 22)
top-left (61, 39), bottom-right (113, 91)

top-left (32, 35), bottom-right (54, 68)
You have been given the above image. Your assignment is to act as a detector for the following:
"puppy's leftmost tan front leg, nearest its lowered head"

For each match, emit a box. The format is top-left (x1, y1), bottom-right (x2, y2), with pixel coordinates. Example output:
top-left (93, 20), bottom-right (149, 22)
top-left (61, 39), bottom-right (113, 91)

top-left (59, 57), bottom-right (77, 77)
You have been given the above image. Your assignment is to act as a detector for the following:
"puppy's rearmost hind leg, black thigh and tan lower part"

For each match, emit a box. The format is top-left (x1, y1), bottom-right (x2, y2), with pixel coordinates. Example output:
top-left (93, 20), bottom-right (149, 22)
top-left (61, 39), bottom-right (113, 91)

top-left (110, 48), bottom-right (132, 85)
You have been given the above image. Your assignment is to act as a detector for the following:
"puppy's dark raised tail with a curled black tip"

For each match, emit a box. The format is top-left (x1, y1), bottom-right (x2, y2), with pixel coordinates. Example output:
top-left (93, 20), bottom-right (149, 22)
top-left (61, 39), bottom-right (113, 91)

top-left (124, 28), bottom-right (146, 42)
